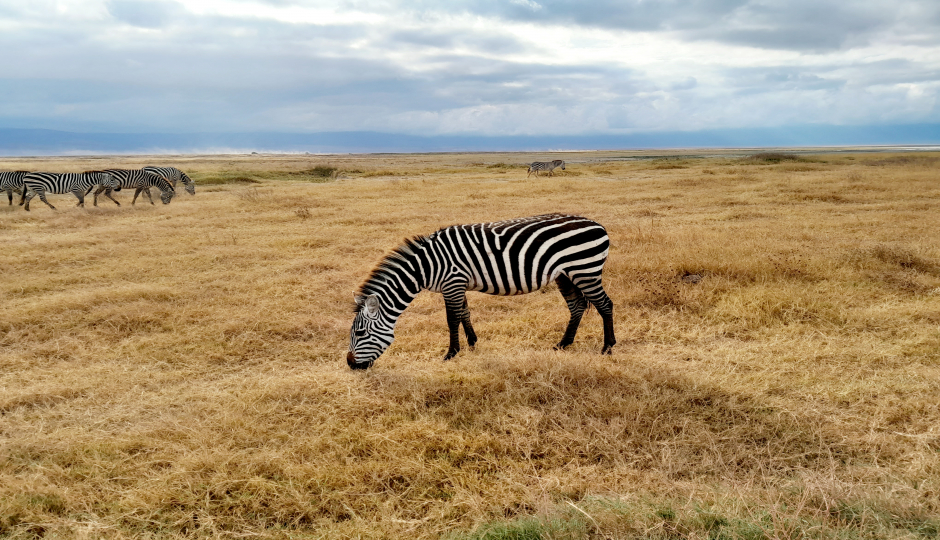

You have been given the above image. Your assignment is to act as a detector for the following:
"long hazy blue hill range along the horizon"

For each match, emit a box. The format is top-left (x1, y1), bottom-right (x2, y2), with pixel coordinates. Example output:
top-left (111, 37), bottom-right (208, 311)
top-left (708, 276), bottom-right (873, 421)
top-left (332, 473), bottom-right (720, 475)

top-left (0, 124), bottom-right (940, 156)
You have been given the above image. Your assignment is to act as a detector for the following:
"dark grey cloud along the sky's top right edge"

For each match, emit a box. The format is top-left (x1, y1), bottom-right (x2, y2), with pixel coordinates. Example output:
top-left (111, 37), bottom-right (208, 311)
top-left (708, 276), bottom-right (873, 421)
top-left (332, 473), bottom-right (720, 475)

top-left (422, 0), bottom-right (940, 51)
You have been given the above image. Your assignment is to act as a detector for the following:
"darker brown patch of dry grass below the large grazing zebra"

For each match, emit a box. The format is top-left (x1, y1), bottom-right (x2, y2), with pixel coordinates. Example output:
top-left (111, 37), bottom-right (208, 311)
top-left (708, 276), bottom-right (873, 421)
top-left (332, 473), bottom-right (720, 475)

top-left (363, 353), bottom-right (864, 480)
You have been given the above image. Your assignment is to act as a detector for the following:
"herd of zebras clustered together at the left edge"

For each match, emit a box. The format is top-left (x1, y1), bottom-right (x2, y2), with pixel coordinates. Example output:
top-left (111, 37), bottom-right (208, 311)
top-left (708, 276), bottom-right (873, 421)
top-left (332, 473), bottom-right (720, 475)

top-left (0, 166), bottom-right (196, 212)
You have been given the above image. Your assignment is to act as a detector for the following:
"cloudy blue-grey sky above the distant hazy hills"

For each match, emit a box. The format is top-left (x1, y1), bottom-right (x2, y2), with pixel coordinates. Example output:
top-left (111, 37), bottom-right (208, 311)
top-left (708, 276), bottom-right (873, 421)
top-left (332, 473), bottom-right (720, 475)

top-left (0, 0), bottom-right (940, 136)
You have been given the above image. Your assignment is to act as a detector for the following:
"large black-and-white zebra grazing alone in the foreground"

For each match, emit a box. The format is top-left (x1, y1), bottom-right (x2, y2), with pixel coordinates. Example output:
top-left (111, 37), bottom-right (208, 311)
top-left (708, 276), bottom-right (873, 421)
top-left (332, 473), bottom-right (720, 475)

top-left (346, 214), bottom-right (617, 369)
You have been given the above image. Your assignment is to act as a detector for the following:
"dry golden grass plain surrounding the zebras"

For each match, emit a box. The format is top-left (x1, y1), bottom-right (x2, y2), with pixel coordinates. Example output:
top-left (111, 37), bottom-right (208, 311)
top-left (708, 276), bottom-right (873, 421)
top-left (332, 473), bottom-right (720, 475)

top-left (0, 152), bottom-right (940, 540)
